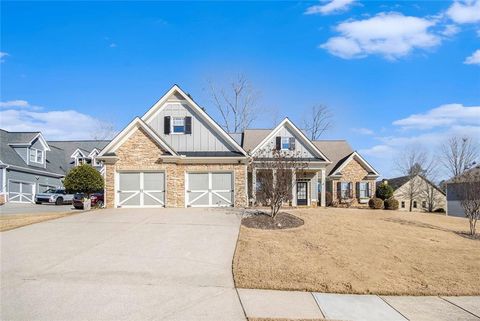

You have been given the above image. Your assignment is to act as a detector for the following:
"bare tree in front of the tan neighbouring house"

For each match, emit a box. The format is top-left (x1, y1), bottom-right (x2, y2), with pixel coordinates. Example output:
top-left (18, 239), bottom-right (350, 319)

top-left (396, 146), bottom-right (433, 212)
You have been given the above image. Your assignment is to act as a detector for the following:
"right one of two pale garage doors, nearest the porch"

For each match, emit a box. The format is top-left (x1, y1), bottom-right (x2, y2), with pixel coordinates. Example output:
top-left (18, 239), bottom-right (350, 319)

top-left (186, 172), bottom-right (233, 207)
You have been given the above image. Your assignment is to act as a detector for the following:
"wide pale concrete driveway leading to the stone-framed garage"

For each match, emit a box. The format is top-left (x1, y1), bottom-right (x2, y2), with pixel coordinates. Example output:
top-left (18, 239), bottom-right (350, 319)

top-left (0, 209), bottom-right (245, 320)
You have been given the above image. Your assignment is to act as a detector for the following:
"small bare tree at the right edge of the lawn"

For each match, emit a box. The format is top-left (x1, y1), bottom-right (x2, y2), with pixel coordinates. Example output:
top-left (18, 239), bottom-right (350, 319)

top-left (448, 167), bottom-right (480, 236)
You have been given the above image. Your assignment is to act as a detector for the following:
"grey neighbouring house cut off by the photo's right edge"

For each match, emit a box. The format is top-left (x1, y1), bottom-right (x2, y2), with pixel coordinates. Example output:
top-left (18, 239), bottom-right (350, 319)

top-left (446, 165), bottom-right (480, 217)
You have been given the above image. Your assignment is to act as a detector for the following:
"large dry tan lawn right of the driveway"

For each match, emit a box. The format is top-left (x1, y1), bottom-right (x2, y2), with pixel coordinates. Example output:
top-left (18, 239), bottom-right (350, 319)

top-left (233, 208), bottom-right (480, 295)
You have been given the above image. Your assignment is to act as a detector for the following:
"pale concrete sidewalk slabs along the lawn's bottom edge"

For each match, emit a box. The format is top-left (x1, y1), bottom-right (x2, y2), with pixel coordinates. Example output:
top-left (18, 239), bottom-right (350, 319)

top-left (238, 289), bottom-right (480, 321)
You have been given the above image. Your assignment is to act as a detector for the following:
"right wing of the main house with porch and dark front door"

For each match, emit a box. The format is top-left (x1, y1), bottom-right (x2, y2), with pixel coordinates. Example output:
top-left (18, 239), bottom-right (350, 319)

top-left (242, 118), bottom-right (379, 206)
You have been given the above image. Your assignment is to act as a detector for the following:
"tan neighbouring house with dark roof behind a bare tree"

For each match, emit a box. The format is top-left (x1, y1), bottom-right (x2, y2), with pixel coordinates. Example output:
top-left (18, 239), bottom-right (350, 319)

top-left (378, 175), bottom-right (446, 212)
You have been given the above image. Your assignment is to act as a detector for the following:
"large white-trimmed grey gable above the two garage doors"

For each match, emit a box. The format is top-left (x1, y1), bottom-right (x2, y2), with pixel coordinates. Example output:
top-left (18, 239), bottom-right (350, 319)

top-left (142, 85), bottom-right (246, 156)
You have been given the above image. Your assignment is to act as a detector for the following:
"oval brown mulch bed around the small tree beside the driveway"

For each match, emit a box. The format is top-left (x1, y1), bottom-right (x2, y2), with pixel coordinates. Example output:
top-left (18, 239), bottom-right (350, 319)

top-left (242, 212), bottom-right (304, 230)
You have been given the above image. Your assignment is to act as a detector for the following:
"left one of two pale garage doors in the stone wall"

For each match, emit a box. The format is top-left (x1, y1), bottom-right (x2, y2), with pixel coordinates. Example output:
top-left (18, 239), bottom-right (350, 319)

top-left (117, 172), bottom-right (165, 207)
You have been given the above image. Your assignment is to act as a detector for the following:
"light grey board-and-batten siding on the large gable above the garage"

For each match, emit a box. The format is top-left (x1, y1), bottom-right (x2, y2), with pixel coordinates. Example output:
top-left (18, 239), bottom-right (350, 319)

top-left (148, 103), bottom-right (235, 152)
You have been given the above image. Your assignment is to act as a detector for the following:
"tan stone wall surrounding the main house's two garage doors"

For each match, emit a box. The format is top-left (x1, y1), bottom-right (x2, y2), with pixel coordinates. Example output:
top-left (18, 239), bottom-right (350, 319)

top-left (105, 129), bottom-right (247, 208)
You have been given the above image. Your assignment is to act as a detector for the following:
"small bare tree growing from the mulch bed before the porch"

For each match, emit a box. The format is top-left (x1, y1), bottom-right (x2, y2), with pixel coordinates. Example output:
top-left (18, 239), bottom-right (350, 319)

top-left (251, 150), bottom-right (306, 219)
